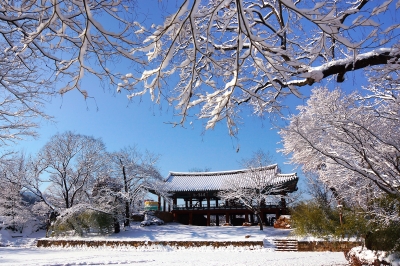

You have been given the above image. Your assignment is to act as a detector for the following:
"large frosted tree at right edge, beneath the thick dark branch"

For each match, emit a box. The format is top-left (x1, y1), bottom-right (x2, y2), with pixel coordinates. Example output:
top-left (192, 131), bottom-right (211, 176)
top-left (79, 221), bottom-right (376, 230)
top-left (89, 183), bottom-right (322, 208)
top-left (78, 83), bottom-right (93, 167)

top-left (280, 86), bottom-right (400, 224)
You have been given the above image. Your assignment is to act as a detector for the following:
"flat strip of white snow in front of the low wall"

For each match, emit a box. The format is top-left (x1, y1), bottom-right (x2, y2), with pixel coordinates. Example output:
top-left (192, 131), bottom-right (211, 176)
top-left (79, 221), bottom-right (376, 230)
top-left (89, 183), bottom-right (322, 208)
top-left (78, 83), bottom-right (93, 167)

top-left (0, 247), bottom-right (347, 266)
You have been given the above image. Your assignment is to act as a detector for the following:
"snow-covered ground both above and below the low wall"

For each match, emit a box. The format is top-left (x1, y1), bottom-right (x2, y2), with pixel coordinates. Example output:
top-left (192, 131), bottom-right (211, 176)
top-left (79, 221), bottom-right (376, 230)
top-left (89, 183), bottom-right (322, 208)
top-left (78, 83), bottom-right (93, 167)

top-left (0, 224), bottom-right (347, 266)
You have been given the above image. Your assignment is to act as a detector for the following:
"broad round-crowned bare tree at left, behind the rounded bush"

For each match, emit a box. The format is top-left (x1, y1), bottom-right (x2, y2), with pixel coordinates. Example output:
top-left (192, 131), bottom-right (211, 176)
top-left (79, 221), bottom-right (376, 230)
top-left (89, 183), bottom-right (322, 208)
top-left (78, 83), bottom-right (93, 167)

top-left (36, 131), bottom-right (107, 208)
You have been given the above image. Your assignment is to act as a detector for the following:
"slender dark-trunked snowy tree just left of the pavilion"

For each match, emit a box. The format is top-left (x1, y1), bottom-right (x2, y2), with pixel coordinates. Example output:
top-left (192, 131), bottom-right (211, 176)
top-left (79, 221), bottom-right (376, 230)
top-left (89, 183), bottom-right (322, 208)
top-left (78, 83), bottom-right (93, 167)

top-left (111, 146), bottom-right (162, 226)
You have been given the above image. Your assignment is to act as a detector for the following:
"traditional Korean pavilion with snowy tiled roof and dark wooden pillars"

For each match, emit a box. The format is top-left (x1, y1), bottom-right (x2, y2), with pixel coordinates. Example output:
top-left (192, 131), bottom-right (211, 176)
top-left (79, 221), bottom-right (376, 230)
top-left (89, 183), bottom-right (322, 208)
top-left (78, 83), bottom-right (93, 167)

top-left (155, 164), bottom-right (298, 226)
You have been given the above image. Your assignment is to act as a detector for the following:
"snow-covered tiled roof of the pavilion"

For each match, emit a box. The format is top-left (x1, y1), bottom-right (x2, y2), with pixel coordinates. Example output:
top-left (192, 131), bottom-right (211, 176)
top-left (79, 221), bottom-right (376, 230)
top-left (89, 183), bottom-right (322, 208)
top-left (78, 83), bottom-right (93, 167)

top-left (165, 164), bottom-right (298, 192)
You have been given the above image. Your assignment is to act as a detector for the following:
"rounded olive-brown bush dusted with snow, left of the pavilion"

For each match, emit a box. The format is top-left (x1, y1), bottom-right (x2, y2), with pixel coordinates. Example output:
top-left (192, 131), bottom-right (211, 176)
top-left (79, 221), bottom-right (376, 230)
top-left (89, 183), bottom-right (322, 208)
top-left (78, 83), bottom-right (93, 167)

top-left (52, 210), bottom-right (114, 236)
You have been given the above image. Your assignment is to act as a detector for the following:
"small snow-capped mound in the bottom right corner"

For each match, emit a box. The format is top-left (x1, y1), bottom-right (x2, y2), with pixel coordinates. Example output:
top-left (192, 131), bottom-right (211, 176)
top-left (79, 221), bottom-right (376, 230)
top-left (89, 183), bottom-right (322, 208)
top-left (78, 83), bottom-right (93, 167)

top-left (346, 246), bottom-right (400, 266)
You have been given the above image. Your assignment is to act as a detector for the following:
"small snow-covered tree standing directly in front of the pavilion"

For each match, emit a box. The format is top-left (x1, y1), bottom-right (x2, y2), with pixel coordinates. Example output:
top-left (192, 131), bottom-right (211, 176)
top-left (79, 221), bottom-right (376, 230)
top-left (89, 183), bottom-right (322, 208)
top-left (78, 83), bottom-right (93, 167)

top-left (218, 151), bottom-right (285, 230)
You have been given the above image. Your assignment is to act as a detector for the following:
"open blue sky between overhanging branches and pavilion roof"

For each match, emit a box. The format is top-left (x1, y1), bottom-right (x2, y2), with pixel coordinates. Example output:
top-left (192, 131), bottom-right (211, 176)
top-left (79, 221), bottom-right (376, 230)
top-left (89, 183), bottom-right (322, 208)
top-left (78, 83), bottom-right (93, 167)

top-left (19, 85), bottom-right (304, 177)
